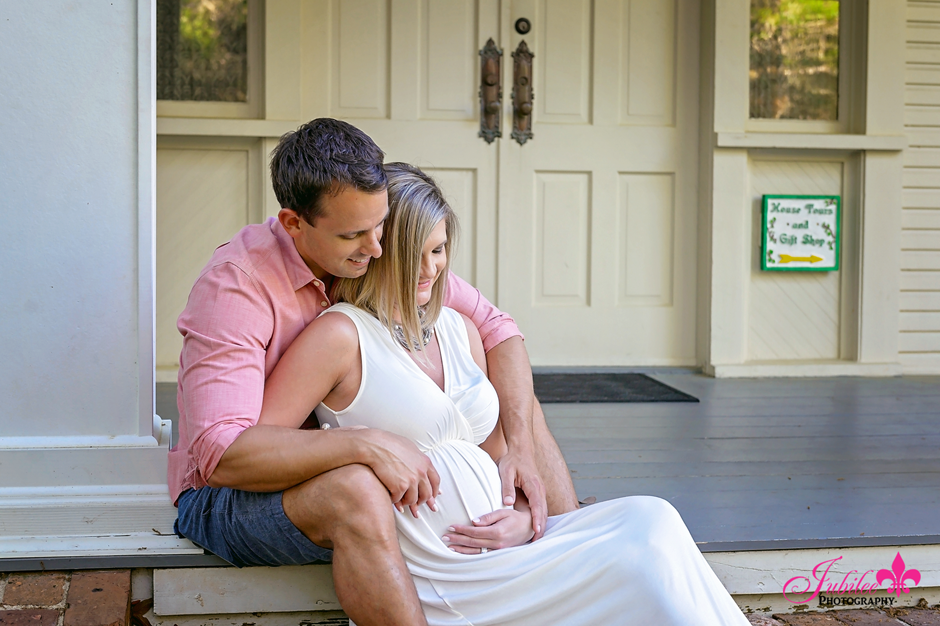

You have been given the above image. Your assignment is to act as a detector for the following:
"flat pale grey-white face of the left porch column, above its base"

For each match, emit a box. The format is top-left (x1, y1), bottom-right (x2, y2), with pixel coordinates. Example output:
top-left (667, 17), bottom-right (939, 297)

top-left (0, 1), bottom-right (139, 437)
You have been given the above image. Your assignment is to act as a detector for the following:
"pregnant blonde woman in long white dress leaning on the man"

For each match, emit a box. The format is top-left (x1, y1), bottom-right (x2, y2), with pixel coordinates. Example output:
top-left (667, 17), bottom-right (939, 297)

top-left (259, 163), bottom-right (747, 626)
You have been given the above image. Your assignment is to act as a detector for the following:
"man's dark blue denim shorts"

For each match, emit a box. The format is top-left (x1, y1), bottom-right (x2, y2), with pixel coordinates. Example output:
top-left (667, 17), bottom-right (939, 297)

top-left (174, 487), bottom-right (333, 567)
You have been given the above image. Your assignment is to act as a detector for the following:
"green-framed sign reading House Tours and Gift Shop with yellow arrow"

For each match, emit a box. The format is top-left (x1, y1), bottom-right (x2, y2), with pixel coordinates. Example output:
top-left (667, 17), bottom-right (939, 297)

top-left (760, 195), bottom-right (842, 272)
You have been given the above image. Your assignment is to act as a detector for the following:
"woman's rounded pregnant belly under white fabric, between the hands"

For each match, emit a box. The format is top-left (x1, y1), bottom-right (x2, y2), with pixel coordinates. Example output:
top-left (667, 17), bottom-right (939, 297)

top-left (397, 440), bottom-right (504, 556)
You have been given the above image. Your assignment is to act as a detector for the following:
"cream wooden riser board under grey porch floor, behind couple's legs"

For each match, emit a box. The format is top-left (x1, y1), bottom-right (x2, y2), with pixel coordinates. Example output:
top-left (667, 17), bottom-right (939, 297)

top-left (153, 545), bottom-right (940, 626)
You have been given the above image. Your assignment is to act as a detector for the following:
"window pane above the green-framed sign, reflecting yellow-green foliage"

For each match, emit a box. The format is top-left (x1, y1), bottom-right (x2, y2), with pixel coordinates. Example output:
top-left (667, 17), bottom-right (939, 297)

top-left (750, 0), bottom-right (839, 121)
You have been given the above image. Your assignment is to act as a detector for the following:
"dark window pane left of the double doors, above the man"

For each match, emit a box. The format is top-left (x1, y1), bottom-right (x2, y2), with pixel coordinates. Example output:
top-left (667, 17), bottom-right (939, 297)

top-left (157, 0), bottom-right (248, 102)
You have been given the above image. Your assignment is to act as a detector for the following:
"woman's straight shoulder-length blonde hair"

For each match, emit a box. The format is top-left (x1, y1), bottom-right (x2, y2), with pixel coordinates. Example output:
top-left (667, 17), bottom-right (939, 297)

top-left (333, 163), bottom-right (459, 353)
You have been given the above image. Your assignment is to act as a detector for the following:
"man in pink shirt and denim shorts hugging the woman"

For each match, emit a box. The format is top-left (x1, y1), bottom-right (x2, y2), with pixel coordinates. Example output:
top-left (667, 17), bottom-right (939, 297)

top-left (168, 119), bottom-right (577, 626)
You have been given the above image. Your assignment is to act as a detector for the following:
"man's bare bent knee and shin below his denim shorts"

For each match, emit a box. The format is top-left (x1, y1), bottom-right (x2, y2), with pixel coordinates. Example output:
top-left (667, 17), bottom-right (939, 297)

top-left (283, 465), bottom-right (427, 626)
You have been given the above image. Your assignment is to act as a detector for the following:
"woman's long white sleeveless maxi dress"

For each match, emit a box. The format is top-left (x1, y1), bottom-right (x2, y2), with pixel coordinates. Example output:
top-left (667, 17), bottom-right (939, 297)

top-left (316, 304), bottom-right (748, 626)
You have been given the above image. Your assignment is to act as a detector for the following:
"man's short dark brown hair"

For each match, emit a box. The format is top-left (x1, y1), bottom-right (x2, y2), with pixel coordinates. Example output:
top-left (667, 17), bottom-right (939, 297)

top-left (271, 117), bottom-right (388, 225)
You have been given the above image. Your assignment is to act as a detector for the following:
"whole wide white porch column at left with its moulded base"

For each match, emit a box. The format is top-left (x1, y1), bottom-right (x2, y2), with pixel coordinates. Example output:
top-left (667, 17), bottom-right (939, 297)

top-left (0, 0), bottom-right (189, 570)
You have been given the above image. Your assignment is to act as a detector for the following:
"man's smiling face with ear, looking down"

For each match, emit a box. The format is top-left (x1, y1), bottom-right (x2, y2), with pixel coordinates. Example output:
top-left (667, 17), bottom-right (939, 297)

top-left (278, 187), bottom-right (388, 280)
